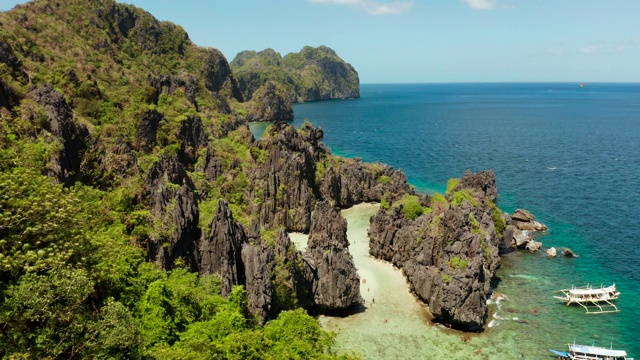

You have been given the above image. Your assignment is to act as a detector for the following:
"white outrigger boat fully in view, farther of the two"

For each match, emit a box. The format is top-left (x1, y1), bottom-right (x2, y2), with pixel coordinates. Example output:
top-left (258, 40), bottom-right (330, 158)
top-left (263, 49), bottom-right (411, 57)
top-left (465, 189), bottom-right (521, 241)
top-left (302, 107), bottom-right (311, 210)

top-left (554, 283), bottom-right (620, 314)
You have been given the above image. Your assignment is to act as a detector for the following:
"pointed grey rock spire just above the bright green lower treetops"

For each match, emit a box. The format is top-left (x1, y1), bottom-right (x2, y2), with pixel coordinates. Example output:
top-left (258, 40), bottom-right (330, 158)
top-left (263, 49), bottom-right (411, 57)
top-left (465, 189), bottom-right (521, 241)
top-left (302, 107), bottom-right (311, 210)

top-left (199, 200), bottom-right (248, 296)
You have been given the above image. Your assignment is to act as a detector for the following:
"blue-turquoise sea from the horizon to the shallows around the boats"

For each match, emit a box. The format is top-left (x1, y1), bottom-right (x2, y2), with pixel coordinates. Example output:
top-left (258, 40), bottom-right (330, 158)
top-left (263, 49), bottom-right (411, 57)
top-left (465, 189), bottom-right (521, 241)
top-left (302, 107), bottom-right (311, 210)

top-left (294, 83), bottom-right (640, 359)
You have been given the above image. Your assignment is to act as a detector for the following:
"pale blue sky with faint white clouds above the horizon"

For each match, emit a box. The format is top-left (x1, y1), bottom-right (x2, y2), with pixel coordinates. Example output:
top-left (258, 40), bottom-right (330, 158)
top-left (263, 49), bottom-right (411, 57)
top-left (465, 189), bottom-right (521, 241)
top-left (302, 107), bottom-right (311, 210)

top-left (0, 0), bottom-right (640, 83)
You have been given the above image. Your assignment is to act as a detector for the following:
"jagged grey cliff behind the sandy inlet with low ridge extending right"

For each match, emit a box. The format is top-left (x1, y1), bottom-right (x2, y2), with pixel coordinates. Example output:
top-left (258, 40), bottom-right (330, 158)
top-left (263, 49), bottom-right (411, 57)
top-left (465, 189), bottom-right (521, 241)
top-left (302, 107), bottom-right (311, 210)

top-left (250, 122), bottom-right (413, 232)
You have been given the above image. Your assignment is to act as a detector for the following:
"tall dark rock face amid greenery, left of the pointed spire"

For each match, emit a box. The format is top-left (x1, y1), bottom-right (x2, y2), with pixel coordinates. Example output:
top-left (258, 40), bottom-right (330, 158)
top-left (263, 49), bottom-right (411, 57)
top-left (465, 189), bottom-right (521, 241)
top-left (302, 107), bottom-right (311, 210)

top-left (144, 155), bottom-right (200, 271)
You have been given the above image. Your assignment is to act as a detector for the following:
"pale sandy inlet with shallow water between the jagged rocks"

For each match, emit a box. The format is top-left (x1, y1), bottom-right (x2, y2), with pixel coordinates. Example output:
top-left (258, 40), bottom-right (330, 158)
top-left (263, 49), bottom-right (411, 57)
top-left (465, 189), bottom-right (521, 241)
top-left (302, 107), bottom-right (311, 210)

top-left (290, 204), bottom-right (527, 359)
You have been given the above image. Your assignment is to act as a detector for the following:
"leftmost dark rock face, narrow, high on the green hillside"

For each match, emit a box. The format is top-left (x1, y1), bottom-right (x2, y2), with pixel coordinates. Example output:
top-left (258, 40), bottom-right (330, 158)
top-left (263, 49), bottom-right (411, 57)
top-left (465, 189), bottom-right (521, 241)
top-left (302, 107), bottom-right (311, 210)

top-left (27, 84), bottom-right (89, 185)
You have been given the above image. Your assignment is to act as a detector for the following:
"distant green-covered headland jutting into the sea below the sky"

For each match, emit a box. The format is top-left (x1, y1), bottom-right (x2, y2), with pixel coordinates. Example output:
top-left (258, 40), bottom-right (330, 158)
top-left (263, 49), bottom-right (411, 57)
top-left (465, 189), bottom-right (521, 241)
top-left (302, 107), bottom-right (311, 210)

top-left (231, 46), bottom-right (360, 102)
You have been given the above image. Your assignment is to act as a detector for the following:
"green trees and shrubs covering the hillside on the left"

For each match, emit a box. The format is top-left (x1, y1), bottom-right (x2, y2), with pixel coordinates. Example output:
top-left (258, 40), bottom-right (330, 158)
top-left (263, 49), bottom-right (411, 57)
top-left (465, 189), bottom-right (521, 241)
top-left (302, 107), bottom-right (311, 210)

top-left (0, 0), bottom-right (356, 359)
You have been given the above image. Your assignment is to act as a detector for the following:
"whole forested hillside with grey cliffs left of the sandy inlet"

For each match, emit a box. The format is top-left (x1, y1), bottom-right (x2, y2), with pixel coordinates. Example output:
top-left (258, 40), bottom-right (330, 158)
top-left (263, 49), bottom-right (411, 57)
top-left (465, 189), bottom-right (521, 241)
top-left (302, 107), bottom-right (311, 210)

top-left (0, 0), bottom-right (393, 359)
